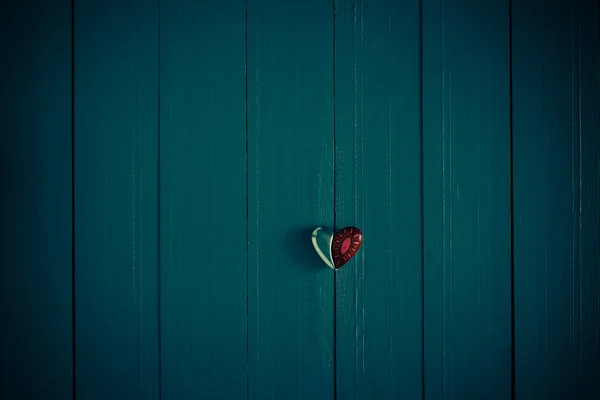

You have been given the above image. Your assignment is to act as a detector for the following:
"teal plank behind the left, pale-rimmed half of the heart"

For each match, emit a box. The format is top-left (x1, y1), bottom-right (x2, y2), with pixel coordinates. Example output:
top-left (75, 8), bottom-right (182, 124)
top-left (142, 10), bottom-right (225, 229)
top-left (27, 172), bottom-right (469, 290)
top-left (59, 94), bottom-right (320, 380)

top-left (248, 0), bottom-right (334, 400)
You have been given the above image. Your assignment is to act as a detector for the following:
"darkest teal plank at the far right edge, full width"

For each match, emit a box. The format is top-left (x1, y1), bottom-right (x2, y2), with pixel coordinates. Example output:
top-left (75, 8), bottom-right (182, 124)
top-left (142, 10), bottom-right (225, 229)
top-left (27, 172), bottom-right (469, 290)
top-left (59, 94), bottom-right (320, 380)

top-left (512, 0), bottom-right (600, 399)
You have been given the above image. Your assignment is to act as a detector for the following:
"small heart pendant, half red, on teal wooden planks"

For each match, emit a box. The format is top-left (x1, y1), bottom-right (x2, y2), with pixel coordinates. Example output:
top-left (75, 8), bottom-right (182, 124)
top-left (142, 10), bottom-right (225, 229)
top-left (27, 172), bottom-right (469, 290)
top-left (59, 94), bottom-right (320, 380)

top-left (312, 226), bottom-right (362, 270)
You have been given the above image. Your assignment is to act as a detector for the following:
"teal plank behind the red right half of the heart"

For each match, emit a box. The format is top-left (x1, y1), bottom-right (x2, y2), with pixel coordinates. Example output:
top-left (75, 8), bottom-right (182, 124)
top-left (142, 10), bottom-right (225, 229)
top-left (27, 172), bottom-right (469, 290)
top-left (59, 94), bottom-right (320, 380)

top-left (335, 0), bottom-right (423, 400)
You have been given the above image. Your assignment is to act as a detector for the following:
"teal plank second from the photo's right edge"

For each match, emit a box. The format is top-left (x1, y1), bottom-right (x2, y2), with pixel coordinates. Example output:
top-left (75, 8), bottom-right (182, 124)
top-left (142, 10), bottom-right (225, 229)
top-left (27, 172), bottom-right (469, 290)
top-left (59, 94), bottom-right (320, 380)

top-left (423, 0), bottom-right (511, 399)
